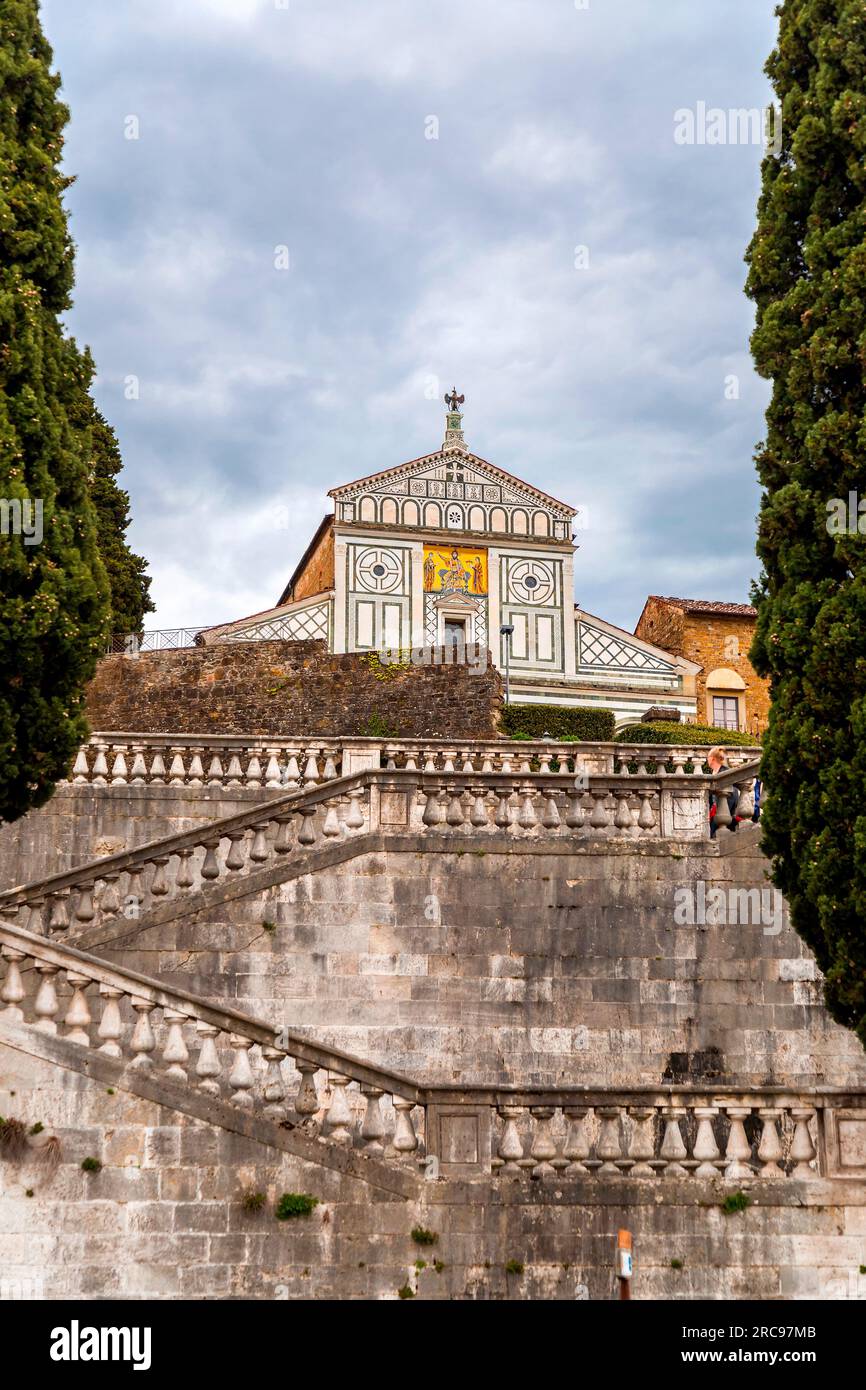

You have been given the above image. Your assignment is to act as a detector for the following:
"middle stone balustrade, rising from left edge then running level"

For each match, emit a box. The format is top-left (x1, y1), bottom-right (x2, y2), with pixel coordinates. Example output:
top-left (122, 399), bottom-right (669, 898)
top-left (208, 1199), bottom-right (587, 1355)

top-left (0, 763), bottom-right (755, 934)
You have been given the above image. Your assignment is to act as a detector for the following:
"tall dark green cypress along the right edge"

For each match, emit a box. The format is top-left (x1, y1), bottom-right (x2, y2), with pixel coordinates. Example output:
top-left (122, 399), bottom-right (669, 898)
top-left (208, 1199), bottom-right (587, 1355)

top-left (746, 0), bottom-right (866, 1043)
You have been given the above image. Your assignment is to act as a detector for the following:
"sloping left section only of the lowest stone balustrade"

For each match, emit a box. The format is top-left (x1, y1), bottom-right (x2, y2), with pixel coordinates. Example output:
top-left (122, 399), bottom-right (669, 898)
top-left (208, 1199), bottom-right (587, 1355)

top-left (0, 923), bottom-right (424, 1161)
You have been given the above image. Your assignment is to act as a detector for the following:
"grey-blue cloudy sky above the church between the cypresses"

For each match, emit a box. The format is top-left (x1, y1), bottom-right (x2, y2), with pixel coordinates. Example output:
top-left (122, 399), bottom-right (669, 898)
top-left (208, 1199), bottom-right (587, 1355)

top-left (43, 0), bottom-right (776, 627)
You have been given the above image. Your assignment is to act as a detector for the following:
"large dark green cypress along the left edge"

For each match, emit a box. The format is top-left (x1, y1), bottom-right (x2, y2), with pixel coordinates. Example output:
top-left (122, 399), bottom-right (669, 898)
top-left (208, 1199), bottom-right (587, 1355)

top-left (0, 0), bottom-right (108, 820)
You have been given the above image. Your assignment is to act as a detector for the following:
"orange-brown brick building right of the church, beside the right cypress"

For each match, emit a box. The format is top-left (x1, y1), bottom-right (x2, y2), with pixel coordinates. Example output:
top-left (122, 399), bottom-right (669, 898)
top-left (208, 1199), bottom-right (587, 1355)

top-left (634, 594), bottom-right (770, 733)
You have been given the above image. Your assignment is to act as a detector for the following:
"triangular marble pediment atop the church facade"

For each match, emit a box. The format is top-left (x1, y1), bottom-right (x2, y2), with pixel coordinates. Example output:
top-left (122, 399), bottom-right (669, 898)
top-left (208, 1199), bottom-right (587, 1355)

top-left (328, 449), bottom-right (577, 521)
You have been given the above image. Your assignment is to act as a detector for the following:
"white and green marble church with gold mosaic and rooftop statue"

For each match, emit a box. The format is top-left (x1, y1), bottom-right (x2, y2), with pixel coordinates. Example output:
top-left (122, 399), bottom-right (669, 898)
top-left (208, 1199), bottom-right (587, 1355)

top-left (200, 393), bottom-right (699, 724)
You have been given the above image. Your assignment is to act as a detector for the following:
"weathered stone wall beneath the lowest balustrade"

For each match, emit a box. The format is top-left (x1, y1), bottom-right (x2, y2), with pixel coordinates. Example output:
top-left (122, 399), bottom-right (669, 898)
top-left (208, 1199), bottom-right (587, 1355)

top-left (0, 1044), bottom-right (866, 1302)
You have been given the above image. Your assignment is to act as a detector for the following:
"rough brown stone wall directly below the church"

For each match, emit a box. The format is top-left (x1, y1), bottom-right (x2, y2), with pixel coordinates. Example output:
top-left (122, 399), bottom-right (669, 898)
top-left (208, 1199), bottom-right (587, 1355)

top-left (88, 641), bottom-right (502, 738)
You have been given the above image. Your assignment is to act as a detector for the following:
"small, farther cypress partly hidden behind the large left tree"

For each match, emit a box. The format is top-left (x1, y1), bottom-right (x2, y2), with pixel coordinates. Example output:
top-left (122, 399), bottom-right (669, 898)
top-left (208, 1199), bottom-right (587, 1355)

top-left (74, 395), bottom-right (154, 635)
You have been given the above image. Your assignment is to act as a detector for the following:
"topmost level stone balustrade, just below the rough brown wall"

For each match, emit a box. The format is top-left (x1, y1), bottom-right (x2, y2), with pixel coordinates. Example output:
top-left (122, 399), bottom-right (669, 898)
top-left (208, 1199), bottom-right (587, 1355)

top-left (70, 733), bottom-right (760, 791)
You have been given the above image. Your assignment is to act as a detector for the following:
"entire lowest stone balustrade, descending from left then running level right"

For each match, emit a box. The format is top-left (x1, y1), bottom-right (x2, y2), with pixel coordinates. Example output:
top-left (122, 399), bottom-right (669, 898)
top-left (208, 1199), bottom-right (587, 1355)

top-left (0, 922), bottom-right (866, 1187)
